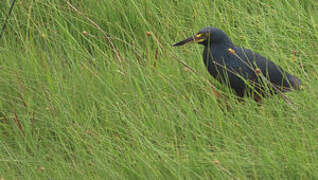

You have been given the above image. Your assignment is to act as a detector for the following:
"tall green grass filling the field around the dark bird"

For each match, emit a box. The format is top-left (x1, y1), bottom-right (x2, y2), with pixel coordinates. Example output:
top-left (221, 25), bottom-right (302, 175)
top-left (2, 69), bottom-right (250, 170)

top-left (0, 0), bottom-right (318, 179)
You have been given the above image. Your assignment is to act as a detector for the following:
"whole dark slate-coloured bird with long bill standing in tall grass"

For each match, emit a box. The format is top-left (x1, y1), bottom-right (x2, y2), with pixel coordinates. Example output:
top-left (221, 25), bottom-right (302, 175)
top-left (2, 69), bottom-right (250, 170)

top-left (173, 27), bottom-right (301, 102)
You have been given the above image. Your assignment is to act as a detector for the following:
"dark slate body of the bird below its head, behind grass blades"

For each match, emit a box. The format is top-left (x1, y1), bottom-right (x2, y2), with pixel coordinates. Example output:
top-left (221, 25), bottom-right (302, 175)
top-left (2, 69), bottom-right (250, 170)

top-left (203, 46), bottom-right (300, 96)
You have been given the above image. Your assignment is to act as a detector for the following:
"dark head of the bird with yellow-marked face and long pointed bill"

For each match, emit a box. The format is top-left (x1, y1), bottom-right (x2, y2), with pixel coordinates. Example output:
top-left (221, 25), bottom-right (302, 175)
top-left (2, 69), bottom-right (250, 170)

top-left (173, 27), bottom-right (232, 46)
